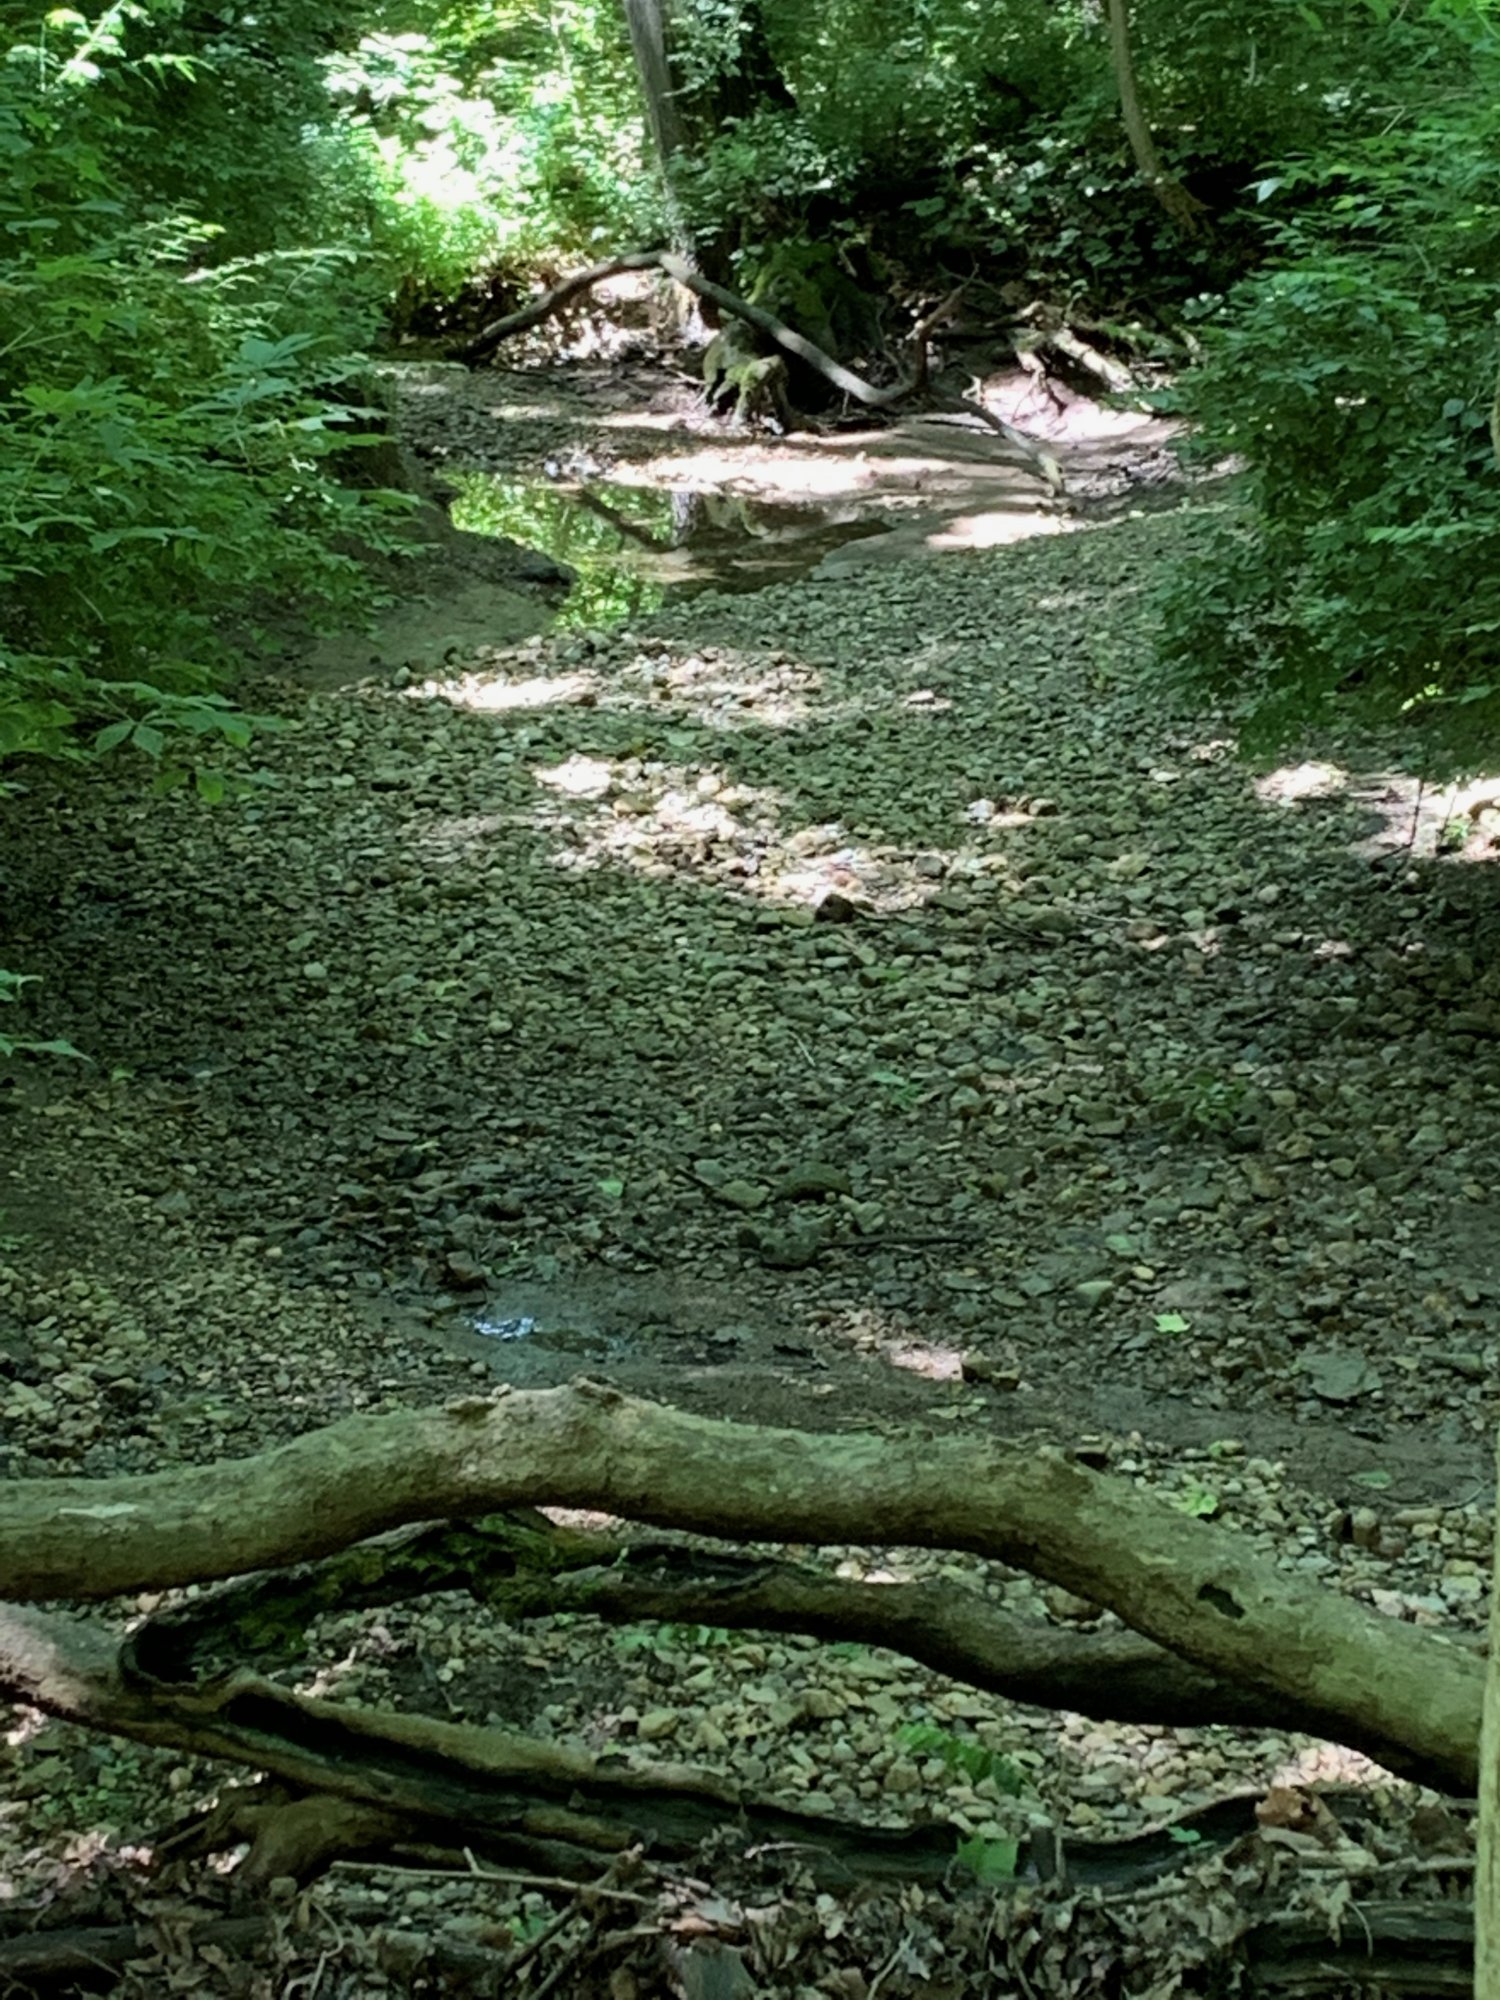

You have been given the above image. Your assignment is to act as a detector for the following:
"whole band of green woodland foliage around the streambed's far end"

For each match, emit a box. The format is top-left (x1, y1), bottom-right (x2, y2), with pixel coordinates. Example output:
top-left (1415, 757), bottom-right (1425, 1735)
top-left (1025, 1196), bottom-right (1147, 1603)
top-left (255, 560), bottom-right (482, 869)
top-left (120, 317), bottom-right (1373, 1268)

top-left (0, 0), bottom-right (1500, 790)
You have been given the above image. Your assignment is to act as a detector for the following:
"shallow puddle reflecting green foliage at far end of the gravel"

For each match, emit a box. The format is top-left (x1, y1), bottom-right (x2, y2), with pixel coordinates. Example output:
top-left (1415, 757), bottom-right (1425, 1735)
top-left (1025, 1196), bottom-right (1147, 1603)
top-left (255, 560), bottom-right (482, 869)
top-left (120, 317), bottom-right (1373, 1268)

top-left (450, 472), bottom-right (890, 628)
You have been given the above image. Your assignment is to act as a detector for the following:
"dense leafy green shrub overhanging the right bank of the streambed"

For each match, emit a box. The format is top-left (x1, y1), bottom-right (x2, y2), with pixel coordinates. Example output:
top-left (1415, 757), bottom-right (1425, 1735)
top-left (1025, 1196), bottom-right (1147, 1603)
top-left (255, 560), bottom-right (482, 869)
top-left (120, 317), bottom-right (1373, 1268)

top-left (1164, 0), bottom-right (1500, 774)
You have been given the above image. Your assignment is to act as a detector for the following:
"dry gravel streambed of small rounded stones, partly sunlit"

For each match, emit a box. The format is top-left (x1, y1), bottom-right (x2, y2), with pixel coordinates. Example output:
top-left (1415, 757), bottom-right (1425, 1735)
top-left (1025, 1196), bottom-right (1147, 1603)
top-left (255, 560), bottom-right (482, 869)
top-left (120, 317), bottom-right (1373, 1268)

top-left (0, 496), bottom-right (1500, 1984)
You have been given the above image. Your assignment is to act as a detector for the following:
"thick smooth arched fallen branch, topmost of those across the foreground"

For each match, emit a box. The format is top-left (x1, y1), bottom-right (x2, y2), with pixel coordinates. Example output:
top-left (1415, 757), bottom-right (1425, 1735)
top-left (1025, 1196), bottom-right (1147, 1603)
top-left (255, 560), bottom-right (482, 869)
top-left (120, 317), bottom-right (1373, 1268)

top-left (0, 1382), bottom-right (1484, 1792)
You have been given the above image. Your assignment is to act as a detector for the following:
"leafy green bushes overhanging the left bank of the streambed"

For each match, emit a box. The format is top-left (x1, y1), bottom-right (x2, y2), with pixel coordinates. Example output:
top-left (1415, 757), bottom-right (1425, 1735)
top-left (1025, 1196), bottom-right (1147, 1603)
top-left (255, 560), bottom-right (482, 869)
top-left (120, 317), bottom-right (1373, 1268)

top-left (0, 8), bottom-right (424, 780)
